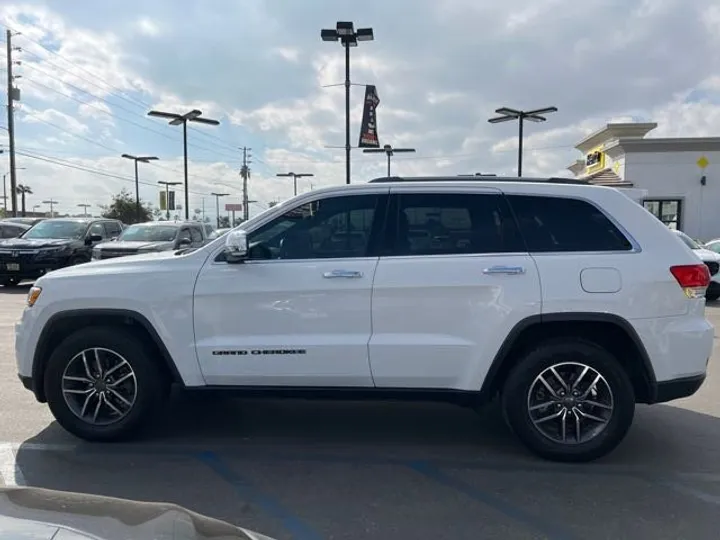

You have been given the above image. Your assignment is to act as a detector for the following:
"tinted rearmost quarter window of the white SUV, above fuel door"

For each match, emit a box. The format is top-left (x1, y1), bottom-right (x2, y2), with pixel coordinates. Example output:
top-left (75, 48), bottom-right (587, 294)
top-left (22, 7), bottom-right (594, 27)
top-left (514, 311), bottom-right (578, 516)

top-left (508, 195), bottom-right (632, 252)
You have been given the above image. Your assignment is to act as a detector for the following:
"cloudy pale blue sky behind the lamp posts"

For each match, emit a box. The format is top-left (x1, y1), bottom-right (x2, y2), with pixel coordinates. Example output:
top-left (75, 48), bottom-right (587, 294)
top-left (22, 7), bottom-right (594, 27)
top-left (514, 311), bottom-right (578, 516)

top-left (0, 0), bottom-right (720, 218)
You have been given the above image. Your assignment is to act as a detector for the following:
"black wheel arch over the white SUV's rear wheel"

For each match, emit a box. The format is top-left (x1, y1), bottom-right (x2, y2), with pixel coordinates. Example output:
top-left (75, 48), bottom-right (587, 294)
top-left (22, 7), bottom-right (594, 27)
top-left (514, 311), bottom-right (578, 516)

top-left (480, 312), bottom-right (657, 403)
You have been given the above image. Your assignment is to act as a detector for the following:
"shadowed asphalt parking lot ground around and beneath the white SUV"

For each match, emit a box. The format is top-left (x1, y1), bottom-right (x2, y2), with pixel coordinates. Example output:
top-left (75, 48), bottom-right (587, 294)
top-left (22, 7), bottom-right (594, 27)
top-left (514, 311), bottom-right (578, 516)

top-left (0, 287), bottom-right (720, 540)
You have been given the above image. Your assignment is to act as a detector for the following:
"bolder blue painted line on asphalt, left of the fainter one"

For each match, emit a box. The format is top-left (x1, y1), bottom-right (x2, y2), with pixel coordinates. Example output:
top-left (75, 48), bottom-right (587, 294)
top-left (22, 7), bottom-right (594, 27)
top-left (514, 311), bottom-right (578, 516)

top-left (195, 452), bottom-right (322, 540)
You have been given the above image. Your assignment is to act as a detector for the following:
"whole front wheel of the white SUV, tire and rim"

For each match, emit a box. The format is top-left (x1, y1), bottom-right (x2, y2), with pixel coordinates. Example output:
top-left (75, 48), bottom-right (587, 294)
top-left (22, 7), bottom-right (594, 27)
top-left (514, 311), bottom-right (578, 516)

top-left (44, 327), bottom-right (165, 441)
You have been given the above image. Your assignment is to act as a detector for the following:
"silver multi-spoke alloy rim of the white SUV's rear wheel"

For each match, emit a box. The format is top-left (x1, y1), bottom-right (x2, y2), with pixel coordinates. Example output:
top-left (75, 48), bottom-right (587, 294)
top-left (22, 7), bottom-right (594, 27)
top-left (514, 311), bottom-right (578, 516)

top-left (527, 362), bottom-right (615, 445)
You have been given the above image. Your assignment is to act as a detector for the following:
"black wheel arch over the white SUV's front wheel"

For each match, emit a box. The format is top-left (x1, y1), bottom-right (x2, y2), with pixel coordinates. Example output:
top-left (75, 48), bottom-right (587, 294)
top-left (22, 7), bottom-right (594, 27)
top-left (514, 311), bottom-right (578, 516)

top-left (32, 309), bottom-right (183, 403)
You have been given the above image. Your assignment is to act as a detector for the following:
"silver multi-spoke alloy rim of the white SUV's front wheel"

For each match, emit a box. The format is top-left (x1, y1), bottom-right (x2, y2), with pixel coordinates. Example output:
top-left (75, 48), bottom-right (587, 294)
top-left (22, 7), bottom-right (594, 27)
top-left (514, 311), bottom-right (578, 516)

top-left (62, 347), bottom-right (137, 426)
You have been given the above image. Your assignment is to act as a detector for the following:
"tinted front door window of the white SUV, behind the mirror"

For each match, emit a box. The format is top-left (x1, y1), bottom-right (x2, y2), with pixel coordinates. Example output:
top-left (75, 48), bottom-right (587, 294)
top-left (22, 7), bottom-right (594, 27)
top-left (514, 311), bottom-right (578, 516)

top-left (249, 195), bottom-right (380, 259)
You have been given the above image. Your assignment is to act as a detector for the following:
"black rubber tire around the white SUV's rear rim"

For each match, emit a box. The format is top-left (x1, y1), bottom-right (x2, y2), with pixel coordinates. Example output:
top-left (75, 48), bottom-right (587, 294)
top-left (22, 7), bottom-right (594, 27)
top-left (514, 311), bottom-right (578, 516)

top-left (502, 338), bottom-right (635, 462)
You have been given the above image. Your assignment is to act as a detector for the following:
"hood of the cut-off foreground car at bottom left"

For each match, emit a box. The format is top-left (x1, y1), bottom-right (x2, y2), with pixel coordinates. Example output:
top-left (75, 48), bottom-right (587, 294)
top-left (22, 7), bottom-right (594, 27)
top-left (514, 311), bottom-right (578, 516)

top-left (0, 488), bottom-right (272, 540)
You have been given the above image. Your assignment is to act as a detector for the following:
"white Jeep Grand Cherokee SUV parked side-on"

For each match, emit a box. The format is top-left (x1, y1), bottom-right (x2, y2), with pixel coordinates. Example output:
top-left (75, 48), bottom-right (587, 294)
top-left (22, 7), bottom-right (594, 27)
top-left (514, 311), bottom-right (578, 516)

top-left (16, 178), bottom-right (714, 461)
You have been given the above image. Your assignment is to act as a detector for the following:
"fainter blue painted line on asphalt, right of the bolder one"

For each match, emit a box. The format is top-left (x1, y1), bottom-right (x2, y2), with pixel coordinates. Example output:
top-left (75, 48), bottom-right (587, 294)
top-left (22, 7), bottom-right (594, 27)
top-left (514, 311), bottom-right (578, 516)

top-left (405, 461), bottom-right (575, 540)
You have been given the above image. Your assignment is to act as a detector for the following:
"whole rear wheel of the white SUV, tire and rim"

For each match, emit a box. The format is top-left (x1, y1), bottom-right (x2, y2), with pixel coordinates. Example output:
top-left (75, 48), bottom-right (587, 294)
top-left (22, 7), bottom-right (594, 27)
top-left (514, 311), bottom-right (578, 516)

top-left (502, 339), bottom-right (635, 462)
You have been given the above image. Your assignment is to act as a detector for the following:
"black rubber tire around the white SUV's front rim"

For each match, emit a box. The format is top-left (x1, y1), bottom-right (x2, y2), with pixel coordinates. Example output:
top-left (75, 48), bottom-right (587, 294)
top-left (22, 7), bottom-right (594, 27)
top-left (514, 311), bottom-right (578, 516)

top-left (44, 326), bottom-right (168, 442)
